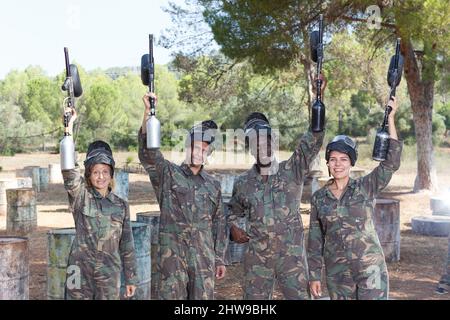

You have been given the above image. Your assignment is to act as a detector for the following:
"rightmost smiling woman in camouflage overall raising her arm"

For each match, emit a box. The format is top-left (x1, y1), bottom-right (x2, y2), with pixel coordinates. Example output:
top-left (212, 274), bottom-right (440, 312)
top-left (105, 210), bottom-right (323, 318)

top-left (308, 98), bottom-right (403, 300)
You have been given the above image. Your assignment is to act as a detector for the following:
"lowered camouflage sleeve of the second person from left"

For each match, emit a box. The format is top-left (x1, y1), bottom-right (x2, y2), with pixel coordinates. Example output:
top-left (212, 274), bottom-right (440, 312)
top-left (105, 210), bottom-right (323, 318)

top-left (212, 186), bottom-right (227, 266)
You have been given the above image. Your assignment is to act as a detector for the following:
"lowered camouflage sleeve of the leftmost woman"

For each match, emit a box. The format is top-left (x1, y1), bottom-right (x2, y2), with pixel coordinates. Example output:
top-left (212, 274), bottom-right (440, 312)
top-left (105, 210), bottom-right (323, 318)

top-left (119, 203), bottom-right (138, 285)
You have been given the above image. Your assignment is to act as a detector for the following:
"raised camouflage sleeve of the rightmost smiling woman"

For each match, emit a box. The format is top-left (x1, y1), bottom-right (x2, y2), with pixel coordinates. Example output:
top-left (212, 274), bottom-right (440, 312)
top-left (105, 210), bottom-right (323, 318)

top-left (361, 139), bottom-right (403, 199)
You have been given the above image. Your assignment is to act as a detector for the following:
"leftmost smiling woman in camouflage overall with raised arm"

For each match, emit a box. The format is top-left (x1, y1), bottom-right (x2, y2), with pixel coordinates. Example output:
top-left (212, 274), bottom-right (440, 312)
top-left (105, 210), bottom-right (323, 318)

top-left (62, 109), bottom-right (137, 300)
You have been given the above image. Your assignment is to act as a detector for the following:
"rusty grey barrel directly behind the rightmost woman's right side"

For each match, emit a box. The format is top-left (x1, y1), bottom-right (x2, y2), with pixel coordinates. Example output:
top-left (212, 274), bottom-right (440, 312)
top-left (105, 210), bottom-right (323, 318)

top-left (373, 199), bottom-right (400, 262)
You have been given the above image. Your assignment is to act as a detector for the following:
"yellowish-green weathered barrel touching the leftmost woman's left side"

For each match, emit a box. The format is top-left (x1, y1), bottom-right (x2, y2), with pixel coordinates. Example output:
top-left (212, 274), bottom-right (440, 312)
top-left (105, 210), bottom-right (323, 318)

top-left (47, 228), bottom-right (76, 300)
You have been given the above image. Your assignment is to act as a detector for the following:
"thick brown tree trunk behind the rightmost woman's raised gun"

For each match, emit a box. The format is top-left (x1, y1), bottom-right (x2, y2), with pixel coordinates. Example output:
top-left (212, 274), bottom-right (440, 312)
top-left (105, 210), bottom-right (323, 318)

top-left (401, 39), bottom-right (438, 192)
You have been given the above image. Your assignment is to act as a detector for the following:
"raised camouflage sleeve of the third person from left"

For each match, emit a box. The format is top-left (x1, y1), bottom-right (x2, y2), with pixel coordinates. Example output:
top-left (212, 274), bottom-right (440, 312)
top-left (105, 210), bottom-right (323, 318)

top-left (286, 128), bottom-right (325, 184)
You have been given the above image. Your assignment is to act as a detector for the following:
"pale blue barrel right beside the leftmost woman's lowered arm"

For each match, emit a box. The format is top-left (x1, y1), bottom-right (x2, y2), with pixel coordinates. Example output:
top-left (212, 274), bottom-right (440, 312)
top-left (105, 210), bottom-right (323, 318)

top-left (120, 221), bottom-right (152, 300)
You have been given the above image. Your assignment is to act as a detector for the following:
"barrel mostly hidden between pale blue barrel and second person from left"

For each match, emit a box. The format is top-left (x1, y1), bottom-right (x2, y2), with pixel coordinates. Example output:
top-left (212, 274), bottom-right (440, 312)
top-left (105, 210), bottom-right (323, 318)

top-left (136, 211), bottom-right (160, 299)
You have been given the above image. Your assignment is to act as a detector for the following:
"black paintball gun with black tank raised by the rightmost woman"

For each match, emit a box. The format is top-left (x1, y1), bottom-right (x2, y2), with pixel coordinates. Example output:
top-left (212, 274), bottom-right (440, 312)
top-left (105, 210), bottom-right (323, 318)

top-left (372, 39), bottom-right (403, 161)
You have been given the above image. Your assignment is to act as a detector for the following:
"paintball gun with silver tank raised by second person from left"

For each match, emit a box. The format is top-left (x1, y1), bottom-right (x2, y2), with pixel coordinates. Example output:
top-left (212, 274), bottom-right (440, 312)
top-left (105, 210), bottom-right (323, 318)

top-left (141, 34), bottom-right (161, 149)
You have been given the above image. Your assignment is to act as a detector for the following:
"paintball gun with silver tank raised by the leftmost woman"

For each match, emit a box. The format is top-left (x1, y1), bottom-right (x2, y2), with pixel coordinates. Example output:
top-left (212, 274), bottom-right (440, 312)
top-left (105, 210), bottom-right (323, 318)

top-left (59, 48), bottom-right (83, 170)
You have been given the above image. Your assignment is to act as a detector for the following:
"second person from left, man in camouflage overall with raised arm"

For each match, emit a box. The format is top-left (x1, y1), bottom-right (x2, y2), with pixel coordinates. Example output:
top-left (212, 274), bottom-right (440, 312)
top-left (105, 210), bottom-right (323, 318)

top-left (139, 93), bottom-right (226, 300)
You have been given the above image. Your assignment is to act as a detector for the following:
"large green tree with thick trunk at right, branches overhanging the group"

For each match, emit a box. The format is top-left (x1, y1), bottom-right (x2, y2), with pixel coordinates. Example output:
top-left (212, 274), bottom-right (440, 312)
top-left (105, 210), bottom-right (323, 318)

top-left (170, 0), bottom-right (450, 190)
